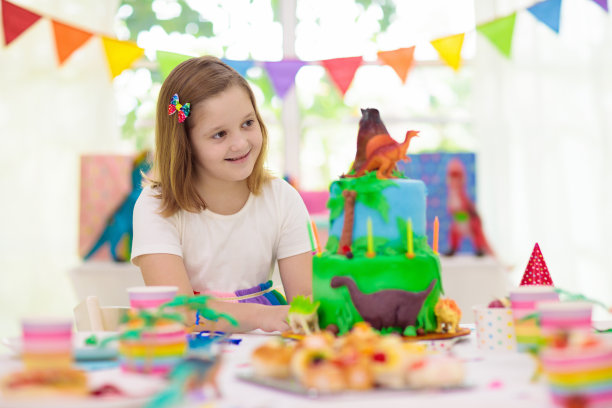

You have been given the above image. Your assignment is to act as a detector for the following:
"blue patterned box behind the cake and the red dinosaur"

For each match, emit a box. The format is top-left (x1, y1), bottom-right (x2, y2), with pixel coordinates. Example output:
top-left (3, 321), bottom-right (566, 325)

top-left (397, 153), bottom-right (490, 254)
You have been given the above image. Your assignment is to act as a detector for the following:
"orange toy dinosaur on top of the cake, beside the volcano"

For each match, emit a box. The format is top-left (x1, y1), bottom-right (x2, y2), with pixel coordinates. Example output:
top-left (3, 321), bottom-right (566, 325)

top-left (355, 130), bottom-right (419, 179)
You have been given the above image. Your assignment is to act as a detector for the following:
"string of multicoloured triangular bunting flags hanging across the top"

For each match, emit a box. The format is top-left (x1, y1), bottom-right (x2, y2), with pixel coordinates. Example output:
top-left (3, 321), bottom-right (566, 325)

top-left (0, 0), bottom-right (609, 98)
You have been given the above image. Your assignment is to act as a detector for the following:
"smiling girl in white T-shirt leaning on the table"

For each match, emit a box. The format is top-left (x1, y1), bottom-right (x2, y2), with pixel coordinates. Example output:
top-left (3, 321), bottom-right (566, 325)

top-left (132, 56), bottom-right (312, 331)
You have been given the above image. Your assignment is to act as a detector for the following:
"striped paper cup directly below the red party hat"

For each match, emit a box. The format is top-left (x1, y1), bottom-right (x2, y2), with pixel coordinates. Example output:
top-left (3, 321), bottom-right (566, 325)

top-left (510, 286), bottom-right (559, 351)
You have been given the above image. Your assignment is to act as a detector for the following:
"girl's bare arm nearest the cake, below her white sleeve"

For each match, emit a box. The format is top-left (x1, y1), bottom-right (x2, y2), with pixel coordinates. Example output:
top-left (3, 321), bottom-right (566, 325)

top-left (278, 252), bottom-right (312, 303)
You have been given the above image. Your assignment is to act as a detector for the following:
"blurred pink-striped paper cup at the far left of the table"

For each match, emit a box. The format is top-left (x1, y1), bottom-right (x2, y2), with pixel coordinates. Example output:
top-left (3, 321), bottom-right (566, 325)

top-left (21, 318), bottom-right (72, 369)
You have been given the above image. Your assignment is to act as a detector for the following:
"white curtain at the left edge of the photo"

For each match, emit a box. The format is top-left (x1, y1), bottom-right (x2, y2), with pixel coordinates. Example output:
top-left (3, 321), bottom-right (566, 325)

top-left (0, 0), bottom-right (124, 336)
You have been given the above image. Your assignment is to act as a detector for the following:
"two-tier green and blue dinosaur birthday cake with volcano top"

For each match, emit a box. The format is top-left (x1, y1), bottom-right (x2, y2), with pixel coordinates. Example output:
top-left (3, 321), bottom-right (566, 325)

top-left (313, 109), bottom-right (461, 336)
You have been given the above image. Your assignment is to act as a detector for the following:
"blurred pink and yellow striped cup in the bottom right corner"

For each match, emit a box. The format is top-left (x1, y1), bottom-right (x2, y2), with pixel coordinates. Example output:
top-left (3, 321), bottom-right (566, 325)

top-left (541, 343), bottom-right (612, 408)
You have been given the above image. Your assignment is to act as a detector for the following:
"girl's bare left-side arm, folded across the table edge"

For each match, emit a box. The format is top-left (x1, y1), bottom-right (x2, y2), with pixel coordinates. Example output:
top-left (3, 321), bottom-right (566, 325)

top-left (134, 254), bottom-right (289, 332)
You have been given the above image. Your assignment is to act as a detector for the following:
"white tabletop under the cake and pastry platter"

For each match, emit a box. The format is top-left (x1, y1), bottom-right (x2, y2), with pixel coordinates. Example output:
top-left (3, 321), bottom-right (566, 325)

top-left (0, 325), bottom-right (592, 408)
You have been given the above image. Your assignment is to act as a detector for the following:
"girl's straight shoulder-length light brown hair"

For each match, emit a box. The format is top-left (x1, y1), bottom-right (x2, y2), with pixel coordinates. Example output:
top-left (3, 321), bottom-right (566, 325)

top-left (149, 56), bottom-right (271, 217)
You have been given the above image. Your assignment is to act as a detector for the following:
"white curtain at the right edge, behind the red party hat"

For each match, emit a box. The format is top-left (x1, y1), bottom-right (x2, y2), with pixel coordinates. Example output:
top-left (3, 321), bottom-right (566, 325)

top-left (473, 0), bottom-right (612, 320)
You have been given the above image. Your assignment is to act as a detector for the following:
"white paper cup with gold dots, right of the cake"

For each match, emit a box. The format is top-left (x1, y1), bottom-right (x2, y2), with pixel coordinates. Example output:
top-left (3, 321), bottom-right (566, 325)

top-left (473, 305), bottom-right (516, 352)
